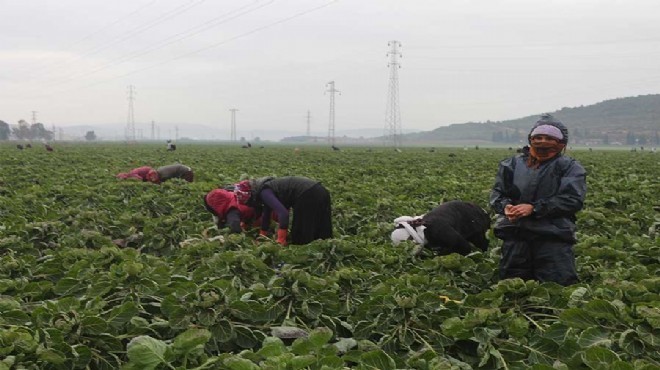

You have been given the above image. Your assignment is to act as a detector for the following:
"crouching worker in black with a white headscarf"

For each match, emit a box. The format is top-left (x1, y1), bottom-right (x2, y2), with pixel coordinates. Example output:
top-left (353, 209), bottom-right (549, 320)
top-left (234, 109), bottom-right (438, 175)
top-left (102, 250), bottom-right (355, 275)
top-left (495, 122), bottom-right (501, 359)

top-left (391, 200), bottom-right (490, 256)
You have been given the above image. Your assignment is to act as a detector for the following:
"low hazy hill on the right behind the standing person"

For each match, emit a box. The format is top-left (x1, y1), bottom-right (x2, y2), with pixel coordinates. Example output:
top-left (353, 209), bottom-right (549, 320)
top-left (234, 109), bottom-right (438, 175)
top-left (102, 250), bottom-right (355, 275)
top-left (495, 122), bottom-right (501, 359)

top-left (403, 94), bottom-right (660, 145)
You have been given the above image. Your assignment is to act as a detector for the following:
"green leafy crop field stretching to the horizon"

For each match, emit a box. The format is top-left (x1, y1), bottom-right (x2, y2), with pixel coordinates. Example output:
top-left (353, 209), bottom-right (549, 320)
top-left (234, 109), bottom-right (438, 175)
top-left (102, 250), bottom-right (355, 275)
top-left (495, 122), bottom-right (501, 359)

top-left (0, 143), bottom-right (660, 370)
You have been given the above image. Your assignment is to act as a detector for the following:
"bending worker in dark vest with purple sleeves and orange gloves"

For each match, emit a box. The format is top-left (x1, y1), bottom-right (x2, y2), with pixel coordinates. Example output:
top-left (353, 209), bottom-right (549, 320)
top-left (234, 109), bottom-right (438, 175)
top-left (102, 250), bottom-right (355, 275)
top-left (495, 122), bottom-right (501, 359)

top-left (234, 176), bottom-right (332, 245)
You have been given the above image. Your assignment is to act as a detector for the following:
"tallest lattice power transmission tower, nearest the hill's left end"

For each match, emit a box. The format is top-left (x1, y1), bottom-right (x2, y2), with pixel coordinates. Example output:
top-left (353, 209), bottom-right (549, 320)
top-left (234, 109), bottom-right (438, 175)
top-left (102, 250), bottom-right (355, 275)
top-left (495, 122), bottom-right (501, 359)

top-left (385, 40), bottom-right (402, 148)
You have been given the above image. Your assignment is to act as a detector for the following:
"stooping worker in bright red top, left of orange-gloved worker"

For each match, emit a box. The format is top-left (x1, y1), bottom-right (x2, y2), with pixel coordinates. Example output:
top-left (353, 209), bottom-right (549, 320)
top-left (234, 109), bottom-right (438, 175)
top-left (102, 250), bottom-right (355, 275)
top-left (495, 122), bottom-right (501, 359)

top-left (204, 189), bottom-right (255, 233)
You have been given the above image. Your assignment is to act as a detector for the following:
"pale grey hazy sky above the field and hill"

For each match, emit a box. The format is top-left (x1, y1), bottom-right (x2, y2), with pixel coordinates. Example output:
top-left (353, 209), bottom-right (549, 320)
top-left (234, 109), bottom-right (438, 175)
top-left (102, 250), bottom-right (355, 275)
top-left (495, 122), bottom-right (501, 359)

top-left (0, 0), bottom-right (660, 135)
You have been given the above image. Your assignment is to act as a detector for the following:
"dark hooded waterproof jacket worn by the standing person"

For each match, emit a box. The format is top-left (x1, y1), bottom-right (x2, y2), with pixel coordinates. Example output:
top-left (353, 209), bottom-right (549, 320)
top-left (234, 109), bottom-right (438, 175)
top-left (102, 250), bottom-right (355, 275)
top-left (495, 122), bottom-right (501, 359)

top-left (490, 116), bottom-right (587, 243)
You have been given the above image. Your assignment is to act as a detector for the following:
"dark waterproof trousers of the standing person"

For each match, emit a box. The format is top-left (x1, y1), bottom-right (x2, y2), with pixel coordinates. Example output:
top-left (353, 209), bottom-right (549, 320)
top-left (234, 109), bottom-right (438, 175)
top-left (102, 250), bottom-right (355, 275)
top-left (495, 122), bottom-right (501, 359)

top-left (500, 238), bottom-right (578, 286)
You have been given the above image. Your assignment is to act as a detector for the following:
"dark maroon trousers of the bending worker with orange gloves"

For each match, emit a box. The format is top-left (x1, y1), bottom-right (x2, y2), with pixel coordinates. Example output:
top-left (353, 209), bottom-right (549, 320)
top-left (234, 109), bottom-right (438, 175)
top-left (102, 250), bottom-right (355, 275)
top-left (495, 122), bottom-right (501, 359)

top-left (291, 184), bottom-right (332, 245)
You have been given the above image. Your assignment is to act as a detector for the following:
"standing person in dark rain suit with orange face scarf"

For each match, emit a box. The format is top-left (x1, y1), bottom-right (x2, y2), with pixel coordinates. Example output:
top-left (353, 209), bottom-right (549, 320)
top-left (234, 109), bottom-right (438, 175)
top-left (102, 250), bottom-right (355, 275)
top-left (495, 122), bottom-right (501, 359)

top-left (490, 115), bottom-right (587, 286)
